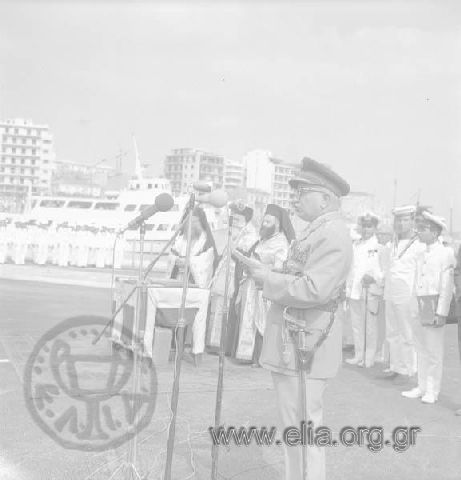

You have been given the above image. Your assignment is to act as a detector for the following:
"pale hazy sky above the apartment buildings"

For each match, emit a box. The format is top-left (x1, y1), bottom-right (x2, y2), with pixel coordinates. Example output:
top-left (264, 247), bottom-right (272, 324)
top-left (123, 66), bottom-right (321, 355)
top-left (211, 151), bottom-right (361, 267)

top-left (0, 0), bottom-right (461, 229)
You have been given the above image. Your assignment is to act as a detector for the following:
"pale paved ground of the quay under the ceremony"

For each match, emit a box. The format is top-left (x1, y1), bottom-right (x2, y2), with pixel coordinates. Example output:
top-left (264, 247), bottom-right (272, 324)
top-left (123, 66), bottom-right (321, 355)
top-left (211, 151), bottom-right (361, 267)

top-left (0, 272), bottom-right (461, 480)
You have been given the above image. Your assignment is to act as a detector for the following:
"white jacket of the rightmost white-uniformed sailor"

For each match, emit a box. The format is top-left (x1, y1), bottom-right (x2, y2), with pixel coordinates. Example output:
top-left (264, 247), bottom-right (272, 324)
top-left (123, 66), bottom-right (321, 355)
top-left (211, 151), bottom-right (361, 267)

top-left (415, 242), bottom-right (456, 317)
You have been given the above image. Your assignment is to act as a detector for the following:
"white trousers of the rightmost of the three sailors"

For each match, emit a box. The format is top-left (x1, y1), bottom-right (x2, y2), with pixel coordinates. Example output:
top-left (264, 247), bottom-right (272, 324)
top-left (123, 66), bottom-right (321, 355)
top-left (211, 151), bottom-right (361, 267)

top-left (413, 319), bottom-right (445, 395)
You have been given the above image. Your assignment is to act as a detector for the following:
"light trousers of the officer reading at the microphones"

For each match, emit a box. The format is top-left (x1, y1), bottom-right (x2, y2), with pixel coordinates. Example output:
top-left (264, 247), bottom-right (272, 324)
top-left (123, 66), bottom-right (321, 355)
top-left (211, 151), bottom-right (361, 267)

top-left (272, 372), bottom-right (327, 480)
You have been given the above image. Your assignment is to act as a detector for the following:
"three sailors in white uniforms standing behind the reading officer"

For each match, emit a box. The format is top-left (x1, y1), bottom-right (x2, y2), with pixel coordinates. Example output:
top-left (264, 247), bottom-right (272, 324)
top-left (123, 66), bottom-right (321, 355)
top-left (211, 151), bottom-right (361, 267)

top-left (346, 206), bottom-right (456, 403)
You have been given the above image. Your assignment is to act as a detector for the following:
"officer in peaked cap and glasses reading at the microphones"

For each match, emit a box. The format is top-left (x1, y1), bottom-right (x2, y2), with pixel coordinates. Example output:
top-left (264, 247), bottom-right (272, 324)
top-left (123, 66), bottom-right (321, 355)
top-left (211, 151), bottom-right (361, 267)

top-left (250, 158), bottom-right (352, 480)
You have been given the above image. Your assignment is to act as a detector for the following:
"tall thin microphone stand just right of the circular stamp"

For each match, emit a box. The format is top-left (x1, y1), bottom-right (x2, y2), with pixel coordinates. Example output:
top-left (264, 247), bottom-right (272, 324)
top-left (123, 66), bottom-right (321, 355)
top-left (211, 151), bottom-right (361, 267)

top-left (164, 193), bottom-right (195, 480)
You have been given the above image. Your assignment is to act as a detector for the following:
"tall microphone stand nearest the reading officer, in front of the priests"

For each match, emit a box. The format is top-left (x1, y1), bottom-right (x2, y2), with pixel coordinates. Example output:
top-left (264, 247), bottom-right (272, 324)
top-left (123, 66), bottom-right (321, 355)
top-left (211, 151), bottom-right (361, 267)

top-left (211, 214), bottom-right (234, 480)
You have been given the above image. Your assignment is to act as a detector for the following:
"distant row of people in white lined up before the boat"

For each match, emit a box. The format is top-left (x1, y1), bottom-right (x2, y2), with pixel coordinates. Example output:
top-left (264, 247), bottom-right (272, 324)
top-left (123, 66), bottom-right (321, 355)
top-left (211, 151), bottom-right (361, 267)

top-left (0, 222), bottom-right (126, 268)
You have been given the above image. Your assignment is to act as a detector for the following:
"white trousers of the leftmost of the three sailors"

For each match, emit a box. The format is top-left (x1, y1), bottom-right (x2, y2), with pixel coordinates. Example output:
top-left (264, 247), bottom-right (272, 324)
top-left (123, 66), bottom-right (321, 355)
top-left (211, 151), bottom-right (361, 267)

top-left (349, 294), bottom-right (379, 365)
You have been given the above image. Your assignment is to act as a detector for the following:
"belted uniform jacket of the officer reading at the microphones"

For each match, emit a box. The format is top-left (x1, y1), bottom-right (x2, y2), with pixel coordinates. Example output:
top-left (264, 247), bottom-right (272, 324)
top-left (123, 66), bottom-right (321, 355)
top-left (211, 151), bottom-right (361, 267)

top-left (260, 212), bottom-right (352, 378)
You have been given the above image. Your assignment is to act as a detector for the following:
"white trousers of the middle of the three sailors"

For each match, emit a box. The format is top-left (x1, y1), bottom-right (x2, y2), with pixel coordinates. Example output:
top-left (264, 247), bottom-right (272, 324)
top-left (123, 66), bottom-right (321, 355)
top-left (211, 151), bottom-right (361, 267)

top-left (386, 297), bottom-right (418, 375)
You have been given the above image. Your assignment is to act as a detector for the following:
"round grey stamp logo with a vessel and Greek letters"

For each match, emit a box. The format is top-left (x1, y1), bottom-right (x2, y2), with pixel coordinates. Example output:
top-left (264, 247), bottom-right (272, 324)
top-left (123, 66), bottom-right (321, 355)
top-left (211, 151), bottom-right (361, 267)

top-left (24, 316), bottom-right (157, 451)
